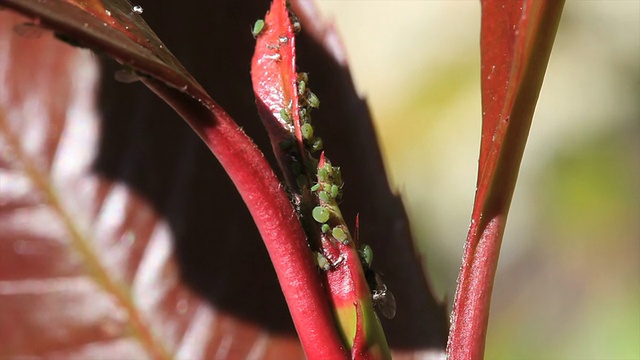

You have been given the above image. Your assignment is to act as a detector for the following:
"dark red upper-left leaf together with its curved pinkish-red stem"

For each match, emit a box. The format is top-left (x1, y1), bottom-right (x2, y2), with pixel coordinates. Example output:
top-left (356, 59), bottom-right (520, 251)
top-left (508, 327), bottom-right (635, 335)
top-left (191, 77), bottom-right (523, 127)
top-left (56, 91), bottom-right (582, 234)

top-left (2, 1), bottom-right (336, 354)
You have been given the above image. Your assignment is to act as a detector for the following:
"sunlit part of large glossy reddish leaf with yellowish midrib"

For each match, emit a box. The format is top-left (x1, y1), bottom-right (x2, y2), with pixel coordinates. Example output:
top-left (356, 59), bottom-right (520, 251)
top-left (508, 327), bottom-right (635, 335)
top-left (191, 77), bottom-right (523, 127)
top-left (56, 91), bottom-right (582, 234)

top-left (0, 11), bottom-right (301, 359)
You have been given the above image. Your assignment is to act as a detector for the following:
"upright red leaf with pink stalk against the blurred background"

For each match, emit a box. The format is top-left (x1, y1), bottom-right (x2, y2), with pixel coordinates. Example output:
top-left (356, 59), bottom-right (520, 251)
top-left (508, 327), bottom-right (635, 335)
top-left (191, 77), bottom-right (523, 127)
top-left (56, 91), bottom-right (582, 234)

top-left (447, 0), bottom-right (564, 359)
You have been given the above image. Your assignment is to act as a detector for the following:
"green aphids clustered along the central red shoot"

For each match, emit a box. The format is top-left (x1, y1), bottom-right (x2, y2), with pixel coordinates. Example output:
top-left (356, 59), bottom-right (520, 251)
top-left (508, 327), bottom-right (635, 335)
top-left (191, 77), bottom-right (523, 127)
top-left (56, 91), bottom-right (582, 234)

top-left (252, 9), bottom-right (396, 318)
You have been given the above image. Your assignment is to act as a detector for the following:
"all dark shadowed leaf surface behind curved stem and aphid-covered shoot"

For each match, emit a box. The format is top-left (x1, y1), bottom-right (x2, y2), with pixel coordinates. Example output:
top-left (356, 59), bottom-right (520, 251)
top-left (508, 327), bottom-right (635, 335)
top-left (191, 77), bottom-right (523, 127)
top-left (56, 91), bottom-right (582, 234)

top-left (96, 0), bottom-right (448, 349)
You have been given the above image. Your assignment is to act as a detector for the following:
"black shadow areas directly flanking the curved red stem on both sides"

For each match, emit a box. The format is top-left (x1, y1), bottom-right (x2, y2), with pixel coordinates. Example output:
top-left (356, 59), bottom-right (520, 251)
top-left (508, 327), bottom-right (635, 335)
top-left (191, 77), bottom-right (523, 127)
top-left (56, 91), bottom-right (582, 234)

top-left (96, 1), bottom-right (295, 336)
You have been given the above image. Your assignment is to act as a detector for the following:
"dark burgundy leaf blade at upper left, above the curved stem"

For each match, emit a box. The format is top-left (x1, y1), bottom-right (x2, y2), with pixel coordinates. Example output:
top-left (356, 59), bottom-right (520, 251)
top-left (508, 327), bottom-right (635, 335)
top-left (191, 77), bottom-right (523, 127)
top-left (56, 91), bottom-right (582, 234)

top-left (2, 0), bottom-right (208, 101)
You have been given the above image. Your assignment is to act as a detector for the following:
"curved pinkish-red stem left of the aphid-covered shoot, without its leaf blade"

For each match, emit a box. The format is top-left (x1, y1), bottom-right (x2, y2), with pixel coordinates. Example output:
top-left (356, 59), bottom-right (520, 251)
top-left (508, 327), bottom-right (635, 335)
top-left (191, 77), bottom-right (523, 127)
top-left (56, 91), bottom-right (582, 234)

top-left (144, 78), bottom-right (347, 359)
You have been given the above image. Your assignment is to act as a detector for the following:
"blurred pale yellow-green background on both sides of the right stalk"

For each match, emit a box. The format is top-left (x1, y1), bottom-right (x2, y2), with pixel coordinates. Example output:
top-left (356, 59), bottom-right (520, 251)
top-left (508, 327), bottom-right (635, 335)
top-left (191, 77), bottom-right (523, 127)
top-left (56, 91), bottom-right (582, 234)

top-left (317, 0), bottom-right (640, 359)
